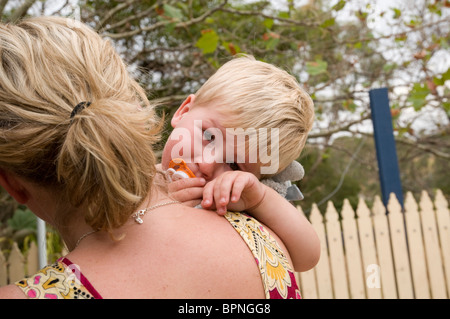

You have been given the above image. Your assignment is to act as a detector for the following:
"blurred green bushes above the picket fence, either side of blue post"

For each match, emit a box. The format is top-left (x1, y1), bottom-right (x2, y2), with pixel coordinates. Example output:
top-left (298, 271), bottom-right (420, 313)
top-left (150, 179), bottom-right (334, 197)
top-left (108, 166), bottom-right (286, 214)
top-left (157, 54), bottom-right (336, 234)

top-left (296, 136), bottom-right (450, 213)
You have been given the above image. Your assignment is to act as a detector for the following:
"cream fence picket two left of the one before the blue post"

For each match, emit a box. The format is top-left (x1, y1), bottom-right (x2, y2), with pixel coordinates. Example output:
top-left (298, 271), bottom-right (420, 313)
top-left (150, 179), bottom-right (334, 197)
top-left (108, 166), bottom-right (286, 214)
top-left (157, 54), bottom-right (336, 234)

top-left (356, 197), bottom-right (381, 299)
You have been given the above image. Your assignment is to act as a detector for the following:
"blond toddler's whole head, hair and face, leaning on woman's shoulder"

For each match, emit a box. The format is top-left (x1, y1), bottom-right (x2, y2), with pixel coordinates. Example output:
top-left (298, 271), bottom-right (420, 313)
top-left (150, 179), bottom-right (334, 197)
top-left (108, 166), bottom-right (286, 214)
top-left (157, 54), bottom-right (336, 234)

top-left (163, 56), bottom-right (314, 178)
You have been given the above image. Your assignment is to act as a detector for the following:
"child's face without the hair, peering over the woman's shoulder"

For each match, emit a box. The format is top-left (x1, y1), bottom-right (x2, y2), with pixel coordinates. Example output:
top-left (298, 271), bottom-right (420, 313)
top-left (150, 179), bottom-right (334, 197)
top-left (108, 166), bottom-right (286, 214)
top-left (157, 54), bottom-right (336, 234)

top-left (162, 98), bottom-right (261, 181)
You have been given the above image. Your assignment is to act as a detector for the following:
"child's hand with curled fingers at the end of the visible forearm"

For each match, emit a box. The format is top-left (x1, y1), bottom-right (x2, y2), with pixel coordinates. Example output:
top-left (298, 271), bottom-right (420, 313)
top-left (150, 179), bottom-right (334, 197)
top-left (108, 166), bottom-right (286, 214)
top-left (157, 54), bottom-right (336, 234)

top-left (202, 171), bottom-right (265, 215)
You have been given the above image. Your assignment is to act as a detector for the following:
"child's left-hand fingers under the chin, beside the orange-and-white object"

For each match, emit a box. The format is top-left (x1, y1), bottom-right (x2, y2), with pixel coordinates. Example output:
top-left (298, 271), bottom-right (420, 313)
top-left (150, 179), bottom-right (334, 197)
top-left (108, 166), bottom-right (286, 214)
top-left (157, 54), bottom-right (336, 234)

top-left (168, 177), bottom-right (206, 207)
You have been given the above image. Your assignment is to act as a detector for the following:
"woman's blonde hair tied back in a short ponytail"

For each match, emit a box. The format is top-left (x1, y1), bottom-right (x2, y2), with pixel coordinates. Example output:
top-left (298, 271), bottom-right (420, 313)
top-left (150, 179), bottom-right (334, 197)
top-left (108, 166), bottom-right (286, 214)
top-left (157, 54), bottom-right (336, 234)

top-left (0, 17), bottom-right (160, 233)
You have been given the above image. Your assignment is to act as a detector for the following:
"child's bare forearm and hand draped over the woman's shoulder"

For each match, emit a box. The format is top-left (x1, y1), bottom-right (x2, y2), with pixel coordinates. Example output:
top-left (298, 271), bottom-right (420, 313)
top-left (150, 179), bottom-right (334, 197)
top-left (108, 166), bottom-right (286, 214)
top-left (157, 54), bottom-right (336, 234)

top-left (202, 171), bottom-right (320, 271)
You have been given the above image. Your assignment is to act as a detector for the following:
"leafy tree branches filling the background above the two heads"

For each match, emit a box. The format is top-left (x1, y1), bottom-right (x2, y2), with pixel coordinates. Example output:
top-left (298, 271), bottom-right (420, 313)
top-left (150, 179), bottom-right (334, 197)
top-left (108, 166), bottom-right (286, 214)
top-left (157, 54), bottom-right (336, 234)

top-left (0, 0), bottom-right (450, 208)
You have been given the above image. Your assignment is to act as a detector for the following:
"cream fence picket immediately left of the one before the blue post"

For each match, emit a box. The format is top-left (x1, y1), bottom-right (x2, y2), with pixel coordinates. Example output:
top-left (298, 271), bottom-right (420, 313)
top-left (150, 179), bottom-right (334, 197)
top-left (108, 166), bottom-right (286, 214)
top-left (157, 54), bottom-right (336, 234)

top-left (372, 196), bottom-right (398, 299)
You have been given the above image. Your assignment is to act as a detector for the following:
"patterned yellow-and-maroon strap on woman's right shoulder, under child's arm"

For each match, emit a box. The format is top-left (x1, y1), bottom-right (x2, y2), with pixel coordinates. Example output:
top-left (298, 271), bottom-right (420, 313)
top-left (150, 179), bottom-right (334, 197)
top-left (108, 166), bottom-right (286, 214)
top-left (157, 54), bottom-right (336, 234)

top-left (225, 212), bottom-right (301, 299)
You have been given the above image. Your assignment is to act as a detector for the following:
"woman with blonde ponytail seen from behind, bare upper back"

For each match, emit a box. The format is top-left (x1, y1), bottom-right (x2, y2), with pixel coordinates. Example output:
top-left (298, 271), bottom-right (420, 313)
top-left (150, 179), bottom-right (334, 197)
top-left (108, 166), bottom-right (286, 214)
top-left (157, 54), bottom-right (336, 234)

top-left (0, 17), bottom-right (299, 298)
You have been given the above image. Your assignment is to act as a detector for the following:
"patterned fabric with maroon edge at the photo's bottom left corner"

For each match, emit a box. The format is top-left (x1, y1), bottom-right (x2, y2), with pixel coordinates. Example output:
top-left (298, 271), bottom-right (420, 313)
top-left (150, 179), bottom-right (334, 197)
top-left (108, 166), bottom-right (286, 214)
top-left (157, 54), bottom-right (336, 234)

top-left (16, 258), bottom-right (102, 299)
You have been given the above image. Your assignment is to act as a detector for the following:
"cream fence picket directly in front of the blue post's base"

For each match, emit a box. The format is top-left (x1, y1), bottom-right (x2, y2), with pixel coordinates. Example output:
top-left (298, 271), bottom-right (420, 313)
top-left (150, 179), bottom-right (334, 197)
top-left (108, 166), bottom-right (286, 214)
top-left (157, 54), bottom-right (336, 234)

top-left (388, 193), bottom-right (414, 299)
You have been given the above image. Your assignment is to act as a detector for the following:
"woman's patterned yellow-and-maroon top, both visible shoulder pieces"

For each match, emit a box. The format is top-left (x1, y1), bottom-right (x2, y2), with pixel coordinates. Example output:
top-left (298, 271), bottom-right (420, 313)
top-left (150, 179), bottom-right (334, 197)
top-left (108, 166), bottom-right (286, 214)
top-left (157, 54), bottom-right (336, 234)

top-left (16, 212), bottom-right (301, 299)
